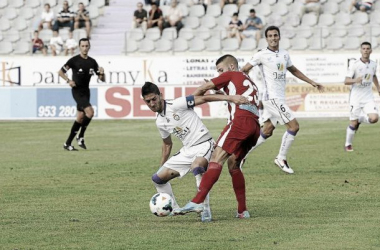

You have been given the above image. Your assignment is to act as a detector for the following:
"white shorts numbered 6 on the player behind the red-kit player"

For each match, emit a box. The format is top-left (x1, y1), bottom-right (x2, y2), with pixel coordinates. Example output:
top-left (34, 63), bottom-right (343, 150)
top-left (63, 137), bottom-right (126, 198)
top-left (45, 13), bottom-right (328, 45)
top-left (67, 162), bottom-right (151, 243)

top-left (260, 99), bottom-right (295, 126)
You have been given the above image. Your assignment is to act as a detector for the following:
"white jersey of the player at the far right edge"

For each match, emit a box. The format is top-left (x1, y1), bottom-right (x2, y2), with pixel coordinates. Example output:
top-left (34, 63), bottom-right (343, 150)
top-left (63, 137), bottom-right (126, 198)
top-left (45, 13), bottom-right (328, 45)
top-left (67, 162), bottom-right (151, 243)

top-left (346, 59), bottom-right (377, 104)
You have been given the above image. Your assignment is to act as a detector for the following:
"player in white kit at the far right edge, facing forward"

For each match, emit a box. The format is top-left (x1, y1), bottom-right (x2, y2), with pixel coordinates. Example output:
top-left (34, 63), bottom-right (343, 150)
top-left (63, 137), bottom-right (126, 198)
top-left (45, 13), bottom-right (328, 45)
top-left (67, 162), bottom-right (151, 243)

top-left (344, 42), bottom-right (380, 152)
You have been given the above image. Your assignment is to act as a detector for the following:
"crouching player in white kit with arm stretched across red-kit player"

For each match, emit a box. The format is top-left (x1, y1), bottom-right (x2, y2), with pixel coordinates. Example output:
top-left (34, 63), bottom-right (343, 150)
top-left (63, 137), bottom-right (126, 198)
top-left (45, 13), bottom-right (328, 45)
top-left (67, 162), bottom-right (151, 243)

top-left (141, 82), bottom-right (249, 222)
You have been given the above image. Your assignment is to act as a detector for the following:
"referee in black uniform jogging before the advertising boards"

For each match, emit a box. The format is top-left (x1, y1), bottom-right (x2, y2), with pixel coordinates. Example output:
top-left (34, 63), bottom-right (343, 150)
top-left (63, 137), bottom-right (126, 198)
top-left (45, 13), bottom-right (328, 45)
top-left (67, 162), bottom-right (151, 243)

top-left (58, 38), bottom-right (105, 151)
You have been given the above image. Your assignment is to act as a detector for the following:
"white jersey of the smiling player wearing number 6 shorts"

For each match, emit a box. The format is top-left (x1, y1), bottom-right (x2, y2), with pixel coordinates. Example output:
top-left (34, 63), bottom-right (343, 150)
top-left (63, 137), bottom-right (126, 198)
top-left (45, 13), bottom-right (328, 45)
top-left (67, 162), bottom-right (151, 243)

top-left (249, 48), bottom-right (293, 101)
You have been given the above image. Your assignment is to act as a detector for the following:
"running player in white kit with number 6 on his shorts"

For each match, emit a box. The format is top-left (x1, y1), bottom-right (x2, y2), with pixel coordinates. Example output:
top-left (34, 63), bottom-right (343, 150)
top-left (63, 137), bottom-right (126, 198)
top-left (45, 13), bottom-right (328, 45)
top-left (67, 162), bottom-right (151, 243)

top-left (242, 26), bottom-right (324, 174)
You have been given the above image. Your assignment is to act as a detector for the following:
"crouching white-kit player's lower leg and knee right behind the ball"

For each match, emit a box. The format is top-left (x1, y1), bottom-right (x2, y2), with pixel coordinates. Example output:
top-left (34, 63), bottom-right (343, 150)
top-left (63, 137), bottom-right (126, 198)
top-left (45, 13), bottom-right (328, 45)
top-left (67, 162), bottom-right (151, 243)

top-left (152, 166), bottom-right (180, 209)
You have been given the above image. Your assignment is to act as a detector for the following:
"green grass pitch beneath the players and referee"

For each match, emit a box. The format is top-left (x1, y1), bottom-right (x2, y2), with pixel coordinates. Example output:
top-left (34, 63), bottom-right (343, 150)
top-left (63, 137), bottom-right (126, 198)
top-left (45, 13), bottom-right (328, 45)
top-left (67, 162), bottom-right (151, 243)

top-left (0, 119), bottom-right (380, 250)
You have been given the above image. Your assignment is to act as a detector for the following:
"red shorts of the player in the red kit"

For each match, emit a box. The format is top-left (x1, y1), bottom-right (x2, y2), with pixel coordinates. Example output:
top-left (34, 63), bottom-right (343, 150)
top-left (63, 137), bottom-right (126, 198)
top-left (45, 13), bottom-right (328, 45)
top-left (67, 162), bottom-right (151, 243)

top-left (216, 116), bottom-right (260, 162)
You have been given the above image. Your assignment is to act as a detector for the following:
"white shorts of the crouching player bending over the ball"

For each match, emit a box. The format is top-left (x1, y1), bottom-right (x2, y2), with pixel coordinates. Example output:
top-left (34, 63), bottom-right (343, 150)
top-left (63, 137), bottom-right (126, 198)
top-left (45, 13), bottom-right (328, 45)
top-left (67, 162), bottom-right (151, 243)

top-left (162, 139), bottom-right (215, 178)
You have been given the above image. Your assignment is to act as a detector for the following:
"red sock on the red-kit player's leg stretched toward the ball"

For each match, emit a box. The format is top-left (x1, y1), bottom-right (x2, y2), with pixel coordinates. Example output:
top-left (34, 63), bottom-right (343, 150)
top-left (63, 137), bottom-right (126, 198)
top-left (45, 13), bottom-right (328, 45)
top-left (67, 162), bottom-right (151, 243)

top-left (192, 162), bottom-right (222, 204)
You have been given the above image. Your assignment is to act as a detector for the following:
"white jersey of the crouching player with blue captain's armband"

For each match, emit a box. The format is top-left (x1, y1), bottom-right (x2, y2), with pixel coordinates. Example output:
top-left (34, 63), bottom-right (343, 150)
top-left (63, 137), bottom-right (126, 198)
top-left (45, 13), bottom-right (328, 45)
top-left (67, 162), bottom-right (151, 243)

top-left (156, 96), bottom-right (211, 147)
